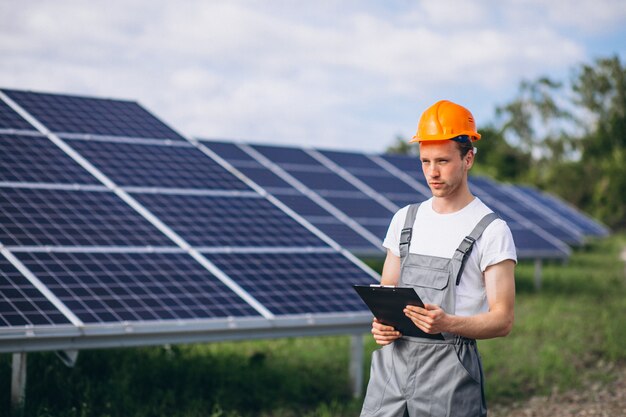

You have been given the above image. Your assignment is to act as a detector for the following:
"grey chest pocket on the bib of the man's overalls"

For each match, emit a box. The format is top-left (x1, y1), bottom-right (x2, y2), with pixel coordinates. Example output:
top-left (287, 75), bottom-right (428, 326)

top-left (401, 258), bottom-right (450, 307)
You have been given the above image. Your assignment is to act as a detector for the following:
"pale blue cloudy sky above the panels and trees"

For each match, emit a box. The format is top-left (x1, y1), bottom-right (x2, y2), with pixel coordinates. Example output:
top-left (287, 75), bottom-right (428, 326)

top-left (0, 0), bottom-right (626, 152)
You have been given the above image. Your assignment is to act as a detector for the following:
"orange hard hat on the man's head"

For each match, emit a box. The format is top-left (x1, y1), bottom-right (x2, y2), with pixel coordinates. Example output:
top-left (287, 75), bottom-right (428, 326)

top-left (410, 100), bottom-right (480, 142)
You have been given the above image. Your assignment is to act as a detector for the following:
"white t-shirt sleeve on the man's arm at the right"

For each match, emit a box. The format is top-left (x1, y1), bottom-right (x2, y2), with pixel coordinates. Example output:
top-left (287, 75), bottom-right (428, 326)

top-left (480, 219), bottom-right (517, 272)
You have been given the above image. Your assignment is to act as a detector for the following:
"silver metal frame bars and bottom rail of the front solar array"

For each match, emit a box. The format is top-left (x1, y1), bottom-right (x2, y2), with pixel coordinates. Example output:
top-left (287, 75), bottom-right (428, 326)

top-left (0, 90), bottom-right (378, 352)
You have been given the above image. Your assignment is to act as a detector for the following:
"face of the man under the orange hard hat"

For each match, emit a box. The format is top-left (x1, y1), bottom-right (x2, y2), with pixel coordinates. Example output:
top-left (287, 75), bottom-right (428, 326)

top-left (420, 140), bottom-right (474, 197)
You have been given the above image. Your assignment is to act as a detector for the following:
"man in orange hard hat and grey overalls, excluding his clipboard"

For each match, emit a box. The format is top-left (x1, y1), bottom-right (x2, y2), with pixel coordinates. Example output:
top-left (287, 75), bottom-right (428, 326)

top-left (361, 100), bottom-right (517, 417)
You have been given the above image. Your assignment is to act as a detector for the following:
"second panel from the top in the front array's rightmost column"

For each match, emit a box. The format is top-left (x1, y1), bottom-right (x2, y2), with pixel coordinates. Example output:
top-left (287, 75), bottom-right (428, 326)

top-left (67, 140), bottom-right (252, 191)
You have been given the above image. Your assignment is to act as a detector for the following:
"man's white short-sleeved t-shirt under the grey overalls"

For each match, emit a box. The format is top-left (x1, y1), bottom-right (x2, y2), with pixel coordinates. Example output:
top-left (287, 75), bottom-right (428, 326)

top-left (383, 197), bottom-right (517, 316)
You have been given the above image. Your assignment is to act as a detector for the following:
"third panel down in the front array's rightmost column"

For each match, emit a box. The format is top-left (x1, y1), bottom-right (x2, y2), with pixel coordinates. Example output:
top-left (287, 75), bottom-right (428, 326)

top-left (133, 193), bottom-right (327, 247)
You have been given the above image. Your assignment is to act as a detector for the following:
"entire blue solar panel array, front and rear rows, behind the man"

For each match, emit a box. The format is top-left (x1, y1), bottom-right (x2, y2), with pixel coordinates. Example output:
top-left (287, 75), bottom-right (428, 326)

top-left (0, 89), bottom-right (608, 351)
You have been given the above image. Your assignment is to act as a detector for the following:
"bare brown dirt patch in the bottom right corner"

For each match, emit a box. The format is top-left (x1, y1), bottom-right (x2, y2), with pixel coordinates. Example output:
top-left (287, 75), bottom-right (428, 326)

top-left (489, 366), bottom-right (626, 417)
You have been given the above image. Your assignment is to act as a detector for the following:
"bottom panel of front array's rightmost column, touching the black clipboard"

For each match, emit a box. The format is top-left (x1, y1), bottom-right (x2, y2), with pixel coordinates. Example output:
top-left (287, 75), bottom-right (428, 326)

top-left (207, 253), bottom-right (376, 315)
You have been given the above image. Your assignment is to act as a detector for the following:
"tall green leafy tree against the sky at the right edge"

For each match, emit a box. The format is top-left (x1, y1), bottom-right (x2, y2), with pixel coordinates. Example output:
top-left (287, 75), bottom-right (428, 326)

top-left (496, 56), bottom-right (626, 228)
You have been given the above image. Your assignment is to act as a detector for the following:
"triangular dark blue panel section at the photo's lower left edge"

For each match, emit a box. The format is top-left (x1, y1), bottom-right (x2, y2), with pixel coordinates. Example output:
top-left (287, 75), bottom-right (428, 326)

top-left (0, 257), bottom-right (70, 328)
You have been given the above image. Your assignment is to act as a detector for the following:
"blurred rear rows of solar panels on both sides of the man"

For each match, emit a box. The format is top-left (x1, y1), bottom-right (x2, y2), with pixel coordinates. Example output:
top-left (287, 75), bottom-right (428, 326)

top-left (202, 139), bottom-right (607, 259)
